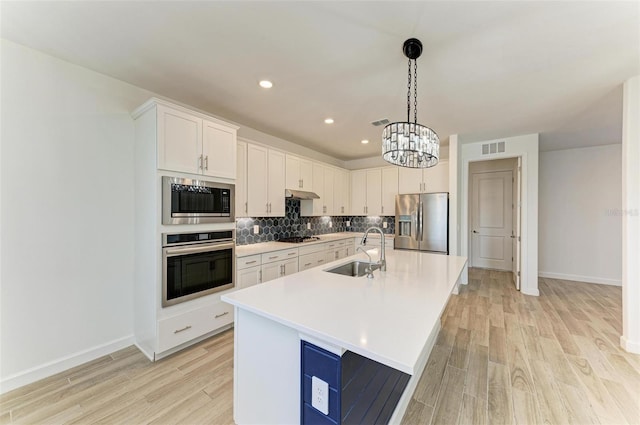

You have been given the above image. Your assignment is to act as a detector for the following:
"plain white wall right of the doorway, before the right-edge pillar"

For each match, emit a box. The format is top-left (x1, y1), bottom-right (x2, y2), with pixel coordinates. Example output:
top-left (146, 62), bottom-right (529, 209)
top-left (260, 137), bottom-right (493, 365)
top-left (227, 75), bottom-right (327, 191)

top-left (539, 145), bottom-right (622, 285)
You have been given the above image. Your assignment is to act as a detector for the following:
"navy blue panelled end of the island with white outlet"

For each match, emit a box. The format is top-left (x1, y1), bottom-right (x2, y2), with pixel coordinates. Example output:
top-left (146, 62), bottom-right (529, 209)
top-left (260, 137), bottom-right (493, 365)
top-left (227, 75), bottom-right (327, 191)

top-left (300, 341), bottom-right (411, 425)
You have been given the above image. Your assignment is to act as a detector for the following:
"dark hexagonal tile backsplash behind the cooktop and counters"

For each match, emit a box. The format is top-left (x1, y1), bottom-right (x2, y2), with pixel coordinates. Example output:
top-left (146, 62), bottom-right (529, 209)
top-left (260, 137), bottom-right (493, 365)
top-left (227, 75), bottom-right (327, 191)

top-left (236, 199), bottom-right (395, 245)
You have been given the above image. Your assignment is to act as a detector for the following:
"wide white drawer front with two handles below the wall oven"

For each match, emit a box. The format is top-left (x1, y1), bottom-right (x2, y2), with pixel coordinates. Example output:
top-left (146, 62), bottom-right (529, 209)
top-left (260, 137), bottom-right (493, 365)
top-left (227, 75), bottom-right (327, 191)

top-left (158, 302), bottom-right (233, 353)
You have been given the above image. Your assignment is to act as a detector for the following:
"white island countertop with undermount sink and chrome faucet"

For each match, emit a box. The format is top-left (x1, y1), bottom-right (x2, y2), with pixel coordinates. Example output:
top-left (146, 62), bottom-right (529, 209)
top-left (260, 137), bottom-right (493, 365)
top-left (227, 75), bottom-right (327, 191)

top-left (222, 249), bottom-right (467, 374)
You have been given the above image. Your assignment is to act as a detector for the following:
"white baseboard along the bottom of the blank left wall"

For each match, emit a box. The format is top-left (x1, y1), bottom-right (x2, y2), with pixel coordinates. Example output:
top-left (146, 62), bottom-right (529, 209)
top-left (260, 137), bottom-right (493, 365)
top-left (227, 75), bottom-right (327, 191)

top-left (0, 335), bottom-right (133, 394)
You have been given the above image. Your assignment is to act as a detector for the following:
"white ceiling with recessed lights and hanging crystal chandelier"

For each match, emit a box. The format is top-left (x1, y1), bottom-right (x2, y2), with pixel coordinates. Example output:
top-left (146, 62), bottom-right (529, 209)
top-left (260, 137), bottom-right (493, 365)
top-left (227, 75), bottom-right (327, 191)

top-left (1, 1), bottom-right (640, 160)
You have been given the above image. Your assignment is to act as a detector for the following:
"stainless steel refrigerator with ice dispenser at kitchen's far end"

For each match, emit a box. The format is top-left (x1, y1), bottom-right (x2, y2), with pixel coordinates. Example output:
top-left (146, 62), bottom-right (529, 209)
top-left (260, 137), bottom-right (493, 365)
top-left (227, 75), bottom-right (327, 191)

top-left (394, 192), bottom-right (449, 254)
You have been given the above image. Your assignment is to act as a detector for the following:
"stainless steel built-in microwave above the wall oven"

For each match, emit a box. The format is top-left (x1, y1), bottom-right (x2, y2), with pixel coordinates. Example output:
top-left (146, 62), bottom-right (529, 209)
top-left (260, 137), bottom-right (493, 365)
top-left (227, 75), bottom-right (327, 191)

top-left (162, 176), bottom-right (235, 224)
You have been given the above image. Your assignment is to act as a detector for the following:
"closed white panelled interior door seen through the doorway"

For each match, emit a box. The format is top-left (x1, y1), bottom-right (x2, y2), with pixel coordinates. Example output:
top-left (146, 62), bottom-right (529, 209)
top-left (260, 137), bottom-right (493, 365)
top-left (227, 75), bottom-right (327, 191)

top-left (471, 171), bottom-right (513, 271)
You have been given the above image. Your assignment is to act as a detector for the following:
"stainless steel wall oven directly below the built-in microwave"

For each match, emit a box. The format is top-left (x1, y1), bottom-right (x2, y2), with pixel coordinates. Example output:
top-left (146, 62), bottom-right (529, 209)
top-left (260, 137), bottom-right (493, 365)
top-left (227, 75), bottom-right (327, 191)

top-left (162, 230), bottom-right (236, 307)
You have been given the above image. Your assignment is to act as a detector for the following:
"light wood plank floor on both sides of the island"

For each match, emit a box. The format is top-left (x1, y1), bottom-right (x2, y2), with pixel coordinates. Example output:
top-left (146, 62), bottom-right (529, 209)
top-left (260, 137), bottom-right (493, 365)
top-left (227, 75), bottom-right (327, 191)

top-left (0, 269), bottom-right (640, 425)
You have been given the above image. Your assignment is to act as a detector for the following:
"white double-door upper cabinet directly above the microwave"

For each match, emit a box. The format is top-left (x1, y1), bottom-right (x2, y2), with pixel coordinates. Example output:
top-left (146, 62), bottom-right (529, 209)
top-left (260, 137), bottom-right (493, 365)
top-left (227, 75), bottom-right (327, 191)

top-left (157, 104), bottom-right (238, 179)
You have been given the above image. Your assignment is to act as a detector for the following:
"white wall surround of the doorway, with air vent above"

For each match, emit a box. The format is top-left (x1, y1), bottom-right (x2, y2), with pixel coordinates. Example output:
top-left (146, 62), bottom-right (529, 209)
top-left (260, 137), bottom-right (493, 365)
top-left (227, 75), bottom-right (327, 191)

top-left (454, 134), bottom-right (540, 296)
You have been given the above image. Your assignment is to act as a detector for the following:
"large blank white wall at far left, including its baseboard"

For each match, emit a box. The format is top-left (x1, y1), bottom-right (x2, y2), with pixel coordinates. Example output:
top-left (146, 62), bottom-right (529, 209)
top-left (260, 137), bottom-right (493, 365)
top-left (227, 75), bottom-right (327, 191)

top-left (0, 40), bottom-right (151, 391)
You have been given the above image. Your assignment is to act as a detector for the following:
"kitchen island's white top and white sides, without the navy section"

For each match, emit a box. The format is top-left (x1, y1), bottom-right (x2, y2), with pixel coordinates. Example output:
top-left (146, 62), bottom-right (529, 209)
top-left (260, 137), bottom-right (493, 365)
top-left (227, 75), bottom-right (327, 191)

top-left (222, 249), bottom-right (466, 424)
